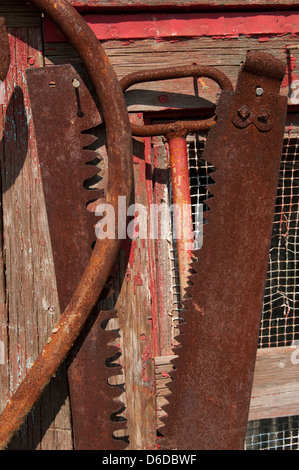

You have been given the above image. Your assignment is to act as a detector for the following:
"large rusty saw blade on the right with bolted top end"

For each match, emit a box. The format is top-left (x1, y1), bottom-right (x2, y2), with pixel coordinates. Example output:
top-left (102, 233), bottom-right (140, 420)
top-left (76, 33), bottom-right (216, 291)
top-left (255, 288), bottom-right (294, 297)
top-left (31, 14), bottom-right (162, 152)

top-left (160, 51), bottom-right (287, 450)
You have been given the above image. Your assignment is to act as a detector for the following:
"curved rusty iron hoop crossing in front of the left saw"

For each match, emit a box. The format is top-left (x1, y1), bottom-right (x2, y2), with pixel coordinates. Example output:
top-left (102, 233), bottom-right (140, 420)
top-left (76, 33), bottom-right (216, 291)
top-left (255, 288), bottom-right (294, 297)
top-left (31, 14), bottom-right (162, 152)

top-left (0, 0), bottom-right (133, 449)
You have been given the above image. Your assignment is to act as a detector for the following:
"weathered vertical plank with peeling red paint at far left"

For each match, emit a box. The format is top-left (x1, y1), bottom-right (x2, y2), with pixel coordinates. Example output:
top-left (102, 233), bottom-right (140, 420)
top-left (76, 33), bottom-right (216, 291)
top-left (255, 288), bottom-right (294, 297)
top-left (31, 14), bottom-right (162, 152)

top-left (0, 27), bottom-right (71, 449)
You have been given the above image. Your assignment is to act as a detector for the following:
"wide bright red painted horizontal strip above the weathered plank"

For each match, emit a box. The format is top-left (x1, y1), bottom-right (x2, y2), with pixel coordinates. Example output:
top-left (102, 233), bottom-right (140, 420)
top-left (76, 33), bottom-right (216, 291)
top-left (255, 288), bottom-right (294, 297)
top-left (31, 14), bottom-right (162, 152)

top-left (44, 11), bottom-right (299, 42)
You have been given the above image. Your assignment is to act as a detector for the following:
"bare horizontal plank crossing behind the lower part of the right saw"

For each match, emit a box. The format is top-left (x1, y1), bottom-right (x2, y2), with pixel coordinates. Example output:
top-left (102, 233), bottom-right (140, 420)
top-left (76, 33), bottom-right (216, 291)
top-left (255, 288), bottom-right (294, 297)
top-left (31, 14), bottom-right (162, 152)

top-left (155, 346), bottom-right (299, 421)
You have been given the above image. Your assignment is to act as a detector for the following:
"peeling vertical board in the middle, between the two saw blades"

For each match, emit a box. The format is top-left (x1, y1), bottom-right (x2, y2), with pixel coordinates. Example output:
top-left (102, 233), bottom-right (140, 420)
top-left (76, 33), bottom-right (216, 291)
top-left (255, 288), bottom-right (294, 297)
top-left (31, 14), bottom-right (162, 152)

top-left (116, 115), bottom-right (157, 450)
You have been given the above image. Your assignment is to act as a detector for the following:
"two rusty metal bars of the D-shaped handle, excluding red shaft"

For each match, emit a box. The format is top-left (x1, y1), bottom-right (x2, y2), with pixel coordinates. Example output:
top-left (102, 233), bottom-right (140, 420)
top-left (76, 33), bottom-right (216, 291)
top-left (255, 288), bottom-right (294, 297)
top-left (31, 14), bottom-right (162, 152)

top-left (120, 65), bottom-right (233, 138)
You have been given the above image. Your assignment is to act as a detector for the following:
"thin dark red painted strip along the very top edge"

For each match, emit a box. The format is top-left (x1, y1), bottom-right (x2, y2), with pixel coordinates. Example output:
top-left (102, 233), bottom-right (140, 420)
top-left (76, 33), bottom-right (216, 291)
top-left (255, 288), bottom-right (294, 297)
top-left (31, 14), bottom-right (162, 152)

top-left (70, 0), bottom-right (299, 11)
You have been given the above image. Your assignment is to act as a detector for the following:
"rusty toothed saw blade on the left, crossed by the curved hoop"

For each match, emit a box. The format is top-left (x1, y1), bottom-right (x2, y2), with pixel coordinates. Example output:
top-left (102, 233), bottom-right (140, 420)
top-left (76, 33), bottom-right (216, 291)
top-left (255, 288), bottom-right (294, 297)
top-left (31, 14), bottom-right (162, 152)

top-left (27, 65), bottom-right (125, 450)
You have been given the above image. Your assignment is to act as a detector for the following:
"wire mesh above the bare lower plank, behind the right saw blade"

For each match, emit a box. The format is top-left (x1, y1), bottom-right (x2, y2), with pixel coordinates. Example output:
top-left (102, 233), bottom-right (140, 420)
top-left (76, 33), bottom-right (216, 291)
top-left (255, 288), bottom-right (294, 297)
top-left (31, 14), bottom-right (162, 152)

top-left (188, 132), bottom-right (299, 347)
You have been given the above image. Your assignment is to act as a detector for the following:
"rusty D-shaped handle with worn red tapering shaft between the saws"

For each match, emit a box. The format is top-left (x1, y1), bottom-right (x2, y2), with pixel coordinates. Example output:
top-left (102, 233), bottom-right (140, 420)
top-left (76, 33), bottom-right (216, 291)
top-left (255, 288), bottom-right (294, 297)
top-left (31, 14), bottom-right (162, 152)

top-left (120, 65), bottom-right (233, 298)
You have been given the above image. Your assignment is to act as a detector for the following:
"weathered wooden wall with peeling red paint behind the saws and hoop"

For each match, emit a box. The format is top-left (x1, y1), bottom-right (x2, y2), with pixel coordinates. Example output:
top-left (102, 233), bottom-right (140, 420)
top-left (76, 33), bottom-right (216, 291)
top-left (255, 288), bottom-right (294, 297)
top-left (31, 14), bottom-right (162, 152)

top-left (0, 0), bottom-right (299, 450)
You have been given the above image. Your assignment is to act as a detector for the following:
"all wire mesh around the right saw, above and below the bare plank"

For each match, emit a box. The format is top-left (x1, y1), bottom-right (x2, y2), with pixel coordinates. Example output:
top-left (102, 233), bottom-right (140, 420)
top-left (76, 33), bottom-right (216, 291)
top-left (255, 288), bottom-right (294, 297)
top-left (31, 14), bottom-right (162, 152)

top-left (165, 127), bottom-right (299, 450)
